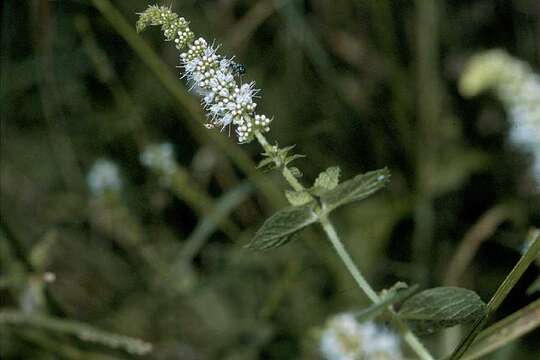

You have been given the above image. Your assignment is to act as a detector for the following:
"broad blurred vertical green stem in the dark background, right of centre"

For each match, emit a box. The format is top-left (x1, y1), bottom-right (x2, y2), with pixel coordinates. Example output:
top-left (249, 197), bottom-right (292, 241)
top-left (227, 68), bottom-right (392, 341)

top-left (413, 0), bottom-right (444, 285)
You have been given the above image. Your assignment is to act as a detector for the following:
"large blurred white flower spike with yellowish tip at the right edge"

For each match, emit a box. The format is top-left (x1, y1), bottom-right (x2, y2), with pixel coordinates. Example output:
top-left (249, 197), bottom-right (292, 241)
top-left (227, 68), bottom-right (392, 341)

top-left (460, 50), bottom-right (540, 183)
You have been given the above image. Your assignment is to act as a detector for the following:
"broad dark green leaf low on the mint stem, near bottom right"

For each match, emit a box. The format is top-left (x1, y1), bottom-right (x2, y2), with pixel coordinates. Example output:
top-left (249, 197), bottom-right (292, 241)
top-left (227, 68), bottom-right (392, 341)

top-left (399, 287), bottom-right (486, 334)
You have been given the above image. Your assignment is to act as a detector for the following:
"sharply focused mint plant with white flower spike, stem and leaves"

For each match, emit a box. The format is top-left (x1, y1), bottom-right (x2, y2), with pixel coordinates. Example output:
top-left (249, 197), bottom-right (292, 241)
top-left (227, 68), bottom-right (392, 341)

top-left (136, 6), bottom-right (540, 360)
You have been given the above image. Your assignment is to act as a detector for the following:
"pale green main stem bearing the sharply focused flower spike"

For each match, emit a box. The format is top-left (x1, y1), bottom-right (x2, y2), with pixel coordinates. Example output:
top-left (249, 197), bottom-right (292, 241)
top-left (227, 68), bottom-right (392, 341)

top-left (255, 132), bottom-right (433, 360)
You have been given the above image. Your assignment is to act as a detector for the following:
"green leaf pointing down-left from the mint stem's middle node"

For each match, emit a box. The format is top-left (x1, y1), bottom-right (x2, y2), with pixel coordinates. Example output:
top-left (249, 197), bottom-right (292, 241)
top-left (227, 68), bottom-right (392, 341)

top-left (247, 205), bottom-right (317, 250)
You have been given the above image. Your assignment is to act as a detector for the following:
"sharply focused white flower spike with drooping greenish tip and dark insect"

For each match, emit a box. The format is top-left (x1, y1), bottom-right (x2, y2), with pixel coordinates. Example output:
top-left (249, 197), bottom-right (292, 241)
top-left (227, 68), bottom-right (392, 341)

top-left (137, 6), bottom-right (271, 143)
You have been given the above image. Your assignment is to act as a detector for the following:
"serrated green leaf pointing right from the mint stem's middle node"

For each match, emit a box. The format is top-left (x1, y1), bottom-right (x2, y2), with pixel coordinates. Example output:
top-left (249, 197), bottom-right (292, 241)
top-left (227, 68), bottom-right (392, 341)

top-left (321, 168), bottom-right (390, 211)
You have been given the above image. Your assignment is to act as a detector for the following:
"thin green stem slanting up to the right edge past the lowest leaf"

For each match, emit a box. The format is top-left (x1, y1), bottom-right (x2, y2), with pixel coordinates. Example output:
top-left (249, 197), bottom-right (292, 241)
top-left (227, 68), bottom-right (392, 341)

top-left (450, 230), bottom-right (540, 360)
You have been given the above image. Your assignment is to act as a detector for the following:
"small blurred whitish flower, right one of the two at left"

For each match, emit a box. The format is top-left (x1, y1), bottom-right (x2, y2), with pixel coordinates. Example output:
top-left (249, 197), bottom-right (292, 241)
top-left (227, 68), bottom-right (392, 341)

top-left (140, 143), bottom-right (177, 184)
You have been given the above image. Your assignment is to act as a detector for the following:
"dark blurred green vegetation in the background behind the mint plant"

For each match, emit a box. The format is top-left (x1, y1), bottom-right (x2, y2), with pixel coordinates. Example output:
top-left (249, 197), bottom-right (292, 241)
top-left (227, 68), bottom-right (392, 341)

top-left (0, 0), bottom-right (540, 359)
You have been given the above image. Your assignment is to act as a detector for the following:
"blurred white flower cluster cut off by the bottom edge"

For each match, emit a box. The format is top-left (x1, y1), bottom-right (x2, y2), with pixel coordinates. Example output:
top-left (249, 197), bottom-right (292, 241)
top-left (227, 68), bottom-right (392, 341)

top-left (320, 313), bottom-right (403, 360)
